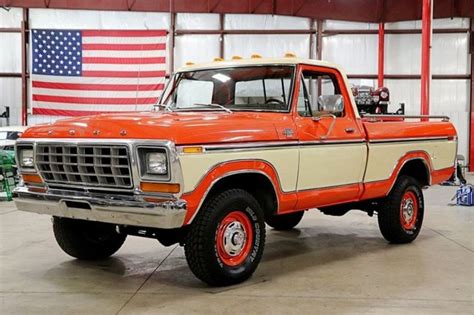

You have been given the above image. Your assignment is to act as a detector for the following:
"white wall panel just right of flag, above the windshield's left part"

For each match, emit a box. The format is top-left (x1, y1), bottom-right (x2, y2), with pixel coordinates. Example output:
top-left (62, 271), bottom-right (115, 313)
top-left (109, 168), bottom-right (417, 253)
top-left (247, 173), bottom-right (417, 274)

top-left (174, 35), bottom-right (220, 69)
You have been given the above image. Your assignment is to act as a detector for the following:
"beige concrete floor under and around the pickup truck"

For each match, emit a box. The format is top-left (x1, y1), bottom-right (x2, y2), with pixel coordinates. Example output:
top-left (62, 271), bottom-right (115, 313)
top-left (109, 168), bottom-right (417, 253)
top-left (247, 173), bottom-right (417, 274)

top-left (0, 177), bottom-right (474, 314)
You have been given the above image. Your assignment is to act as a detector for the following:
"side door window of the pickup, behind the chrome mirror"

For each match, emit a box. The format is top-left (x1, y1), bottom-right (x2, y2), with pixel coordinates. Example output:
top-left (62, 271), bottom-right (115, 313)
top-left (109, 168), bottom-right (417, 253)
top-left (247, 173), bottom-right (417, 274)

top-left (298, 71), bottom-right (344, 117)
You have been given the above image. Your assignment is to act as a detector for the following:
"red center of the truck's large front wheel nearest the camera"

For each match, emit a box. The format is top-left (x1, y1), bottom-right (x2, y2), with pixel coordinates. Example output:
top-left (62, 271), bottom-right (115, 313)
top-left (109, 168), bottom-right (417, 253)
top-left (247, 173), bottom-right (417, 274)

top-left (216, 211), bottom-right (253, 266)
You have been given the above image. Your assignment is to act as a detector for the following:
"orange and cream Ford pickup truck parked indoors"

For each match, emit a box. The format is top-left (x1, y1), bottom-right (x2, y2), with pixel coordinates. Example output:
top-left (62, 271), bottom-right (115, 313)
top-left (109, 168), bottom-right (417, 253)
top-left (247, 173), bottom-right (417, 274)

top-left (14, 55), bottom-right (457, 285)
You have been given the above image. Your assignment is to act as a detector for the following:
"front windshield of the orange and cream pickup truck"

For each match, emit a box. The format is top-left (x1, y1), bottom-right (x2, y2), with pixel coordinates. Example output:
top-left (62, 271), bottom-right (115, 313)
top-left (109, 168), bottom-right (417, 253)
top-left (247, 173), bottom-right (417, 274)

top-left (157, 65), bottom-right (294, 111)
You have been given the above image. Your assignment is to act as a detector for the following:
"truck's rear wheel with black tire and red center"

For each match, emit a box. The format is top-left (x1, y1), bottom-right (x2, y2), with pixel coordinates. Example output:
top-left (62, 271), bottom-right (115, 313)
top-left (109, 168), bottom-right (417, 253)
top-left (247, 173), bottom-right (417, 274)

top-left (378, 175), bottom-right (425, 244)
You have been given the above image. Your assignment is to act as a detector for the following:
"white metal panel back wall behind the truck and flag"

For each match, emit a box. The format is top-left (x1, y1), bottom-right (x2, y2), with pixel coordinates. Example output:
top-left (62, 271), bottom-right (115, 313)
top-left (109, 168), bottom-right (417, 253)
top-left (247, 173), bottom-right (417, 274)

top-left (0, 9), bottom-right (470, 156)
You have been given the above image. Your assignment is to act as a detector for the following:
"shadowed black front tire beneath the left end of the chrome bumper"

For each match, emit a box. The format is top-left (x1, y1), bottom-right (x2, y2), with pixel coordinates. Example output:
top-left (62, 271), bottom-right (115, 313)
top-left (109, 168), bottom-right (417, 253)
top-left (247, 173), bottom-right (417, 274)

top-left (53, 217), bottom-right (127, 260)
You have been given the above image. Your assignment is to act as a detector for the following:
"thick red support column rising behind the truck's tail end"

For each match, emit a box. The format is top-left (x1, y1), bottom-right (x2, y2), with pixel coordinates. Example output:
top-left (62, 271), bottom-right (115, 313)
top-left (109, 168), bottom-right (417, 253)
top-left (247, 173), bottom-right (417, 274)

top-left (421, 0), bottom-right (433, 115)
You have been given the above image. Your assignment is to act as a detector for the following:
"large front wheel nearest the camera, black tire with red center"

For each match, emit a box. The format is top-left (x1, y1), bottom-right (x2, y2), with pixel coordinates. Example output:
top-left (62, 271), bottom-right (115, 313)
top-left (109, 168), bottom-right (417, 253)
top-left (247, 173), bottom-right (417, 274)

top-left (184, 189), bottom-right (265, 286)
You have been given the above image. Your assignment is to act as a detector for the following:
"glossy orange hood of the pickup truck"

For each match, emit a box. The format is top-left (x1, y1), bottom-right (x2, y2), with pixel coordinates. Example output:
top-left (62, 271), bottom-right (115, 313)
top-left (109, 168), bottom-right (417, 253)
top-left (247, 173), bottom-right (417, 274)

top-left (22, 111), bottom-right (290, 144)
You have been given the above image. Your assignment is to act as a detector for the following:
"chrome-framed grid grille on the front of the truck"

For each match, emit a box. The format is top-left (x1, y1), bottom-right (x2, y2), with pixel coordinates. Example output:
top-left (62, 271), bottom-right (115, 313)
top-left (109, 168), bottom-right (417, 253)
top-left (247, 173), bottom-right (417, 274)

top-left (36, 143), bottom-right (132, 188)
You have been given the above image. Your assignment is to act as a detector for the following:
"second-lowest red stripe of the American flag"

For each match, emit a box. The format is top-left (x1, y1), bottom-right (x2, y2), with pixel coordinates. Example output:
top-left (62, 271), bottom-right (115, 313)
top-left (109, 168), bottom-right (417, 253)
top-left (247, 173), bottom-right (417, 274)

top-left (33, 94), bottom-right (158, 105)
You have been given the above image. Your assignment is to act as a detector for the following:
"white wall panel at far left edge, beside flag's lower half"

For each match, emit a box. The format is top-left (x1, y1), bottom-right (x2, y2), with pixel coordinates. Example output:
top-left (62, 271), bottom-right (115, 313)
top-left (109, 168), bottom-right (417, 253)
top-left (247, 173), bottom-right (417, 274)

top-left (0, 78), bottom-right (21, 126)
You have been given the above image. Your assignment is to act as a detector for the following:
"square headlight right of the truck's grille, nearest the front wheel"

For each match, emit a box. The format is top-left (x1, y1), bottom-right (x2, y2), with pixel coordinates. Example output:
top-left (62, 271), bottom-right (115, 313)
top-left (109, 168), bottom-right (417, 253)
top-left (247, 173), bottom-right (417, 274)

top-left (138, 146), bottom-right (170, 180)
